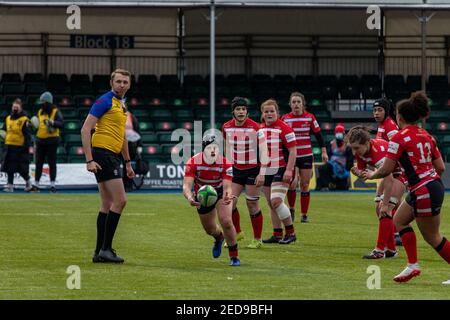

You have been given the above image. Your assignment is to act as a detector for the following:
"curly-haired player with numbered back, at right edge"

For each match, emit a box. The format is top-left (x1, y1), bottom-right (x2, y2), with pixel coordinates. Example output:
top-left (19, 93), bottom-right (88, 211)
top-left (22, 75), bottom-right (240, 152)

top-left (363, 91), bottom-right (450, 282)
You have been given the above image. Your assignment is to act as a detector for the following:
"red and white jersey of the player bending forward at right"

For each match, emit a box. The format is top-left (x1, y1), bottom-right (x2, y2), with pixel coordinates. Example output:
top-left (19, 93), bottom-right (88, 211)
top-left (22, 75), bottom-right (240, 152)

top-left (355, 139), bottom-right (401, 176)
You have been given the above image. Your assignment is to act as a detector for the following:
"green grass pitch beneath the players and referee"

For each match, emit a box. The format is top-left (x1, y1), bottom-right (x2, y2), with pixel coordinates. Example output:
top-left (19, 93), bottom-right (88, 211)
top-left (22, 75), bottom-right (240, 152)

top-left (0, 193), bottom-right (450, 300)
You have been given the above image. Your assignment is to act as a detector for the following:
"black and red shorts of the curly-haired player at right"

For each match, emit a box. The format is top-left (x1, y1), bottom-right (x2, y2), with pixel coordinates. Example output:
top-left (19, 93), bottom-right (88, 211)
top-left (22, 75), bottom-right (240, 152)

top-left (405, 179), bottom-right (445, 217)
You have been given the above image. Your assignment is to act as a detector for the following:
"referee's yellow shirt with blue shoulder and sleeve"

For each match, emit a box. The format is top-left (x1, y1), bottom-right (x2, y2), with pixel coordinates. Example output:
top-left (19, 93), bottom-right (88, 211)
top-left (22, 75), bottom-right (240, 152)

top-left (89, 91), bottom-right (127, 154)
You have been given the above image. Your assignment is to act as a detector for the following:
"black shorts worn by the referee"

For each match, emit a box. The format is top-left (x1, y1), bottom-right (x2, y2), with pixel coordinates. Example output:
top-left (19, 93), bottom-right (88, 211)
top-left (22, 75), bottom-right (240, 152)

top-left (92, 148), bottom-right (122, 182)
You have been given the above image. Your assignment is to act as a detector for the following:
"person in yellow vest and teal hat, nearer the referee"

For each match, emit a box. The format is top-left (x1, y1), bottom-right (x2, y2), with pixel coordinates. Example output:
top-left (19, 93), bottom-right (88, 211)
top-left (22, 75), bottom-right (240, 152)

top-left (31, 91), bottom-right (64, 193)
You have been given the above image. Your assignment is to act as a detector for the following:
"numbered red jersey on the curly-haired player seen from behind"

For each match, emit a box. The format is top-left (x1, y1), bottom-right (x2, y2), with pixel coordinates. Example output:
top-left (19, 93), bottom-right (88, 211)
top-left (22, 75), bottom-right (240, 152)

top-left (387, 125), bottom-right (441, 191)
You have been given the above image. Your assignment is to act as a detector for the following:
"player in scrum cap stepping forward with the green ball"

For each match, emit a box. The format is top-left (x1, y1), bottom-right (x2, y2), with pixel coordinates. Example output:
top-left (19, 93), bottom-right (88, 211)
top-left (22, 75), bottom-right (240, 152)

top-left (183, 135), bottom-right (241, 266)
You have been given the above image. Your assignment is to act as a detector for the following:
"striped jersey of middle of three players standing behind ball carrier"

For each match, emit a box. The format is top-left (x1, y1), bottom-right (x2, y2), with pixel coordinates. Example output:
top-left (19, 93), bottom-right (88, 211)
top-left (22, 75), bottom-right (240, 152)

top-left (260, 119), bottom-right (296, 168)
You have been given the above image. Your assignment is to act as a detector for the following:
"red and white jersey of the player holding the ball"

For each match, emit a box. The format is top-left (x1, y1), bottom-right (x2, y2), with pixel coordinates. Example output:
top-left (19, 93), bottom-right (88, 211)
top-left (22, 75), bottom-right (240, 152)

top-left (184, 152), bottom-right (233, 192)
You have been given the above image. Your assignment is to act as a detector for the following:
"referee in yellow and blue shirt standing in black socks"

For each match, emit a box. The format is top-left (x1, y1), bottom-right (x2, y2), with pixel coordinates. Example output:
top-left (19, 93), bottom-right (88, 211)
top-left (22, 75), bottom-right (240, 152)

top-left (81, 69), bottom-right (134, 263)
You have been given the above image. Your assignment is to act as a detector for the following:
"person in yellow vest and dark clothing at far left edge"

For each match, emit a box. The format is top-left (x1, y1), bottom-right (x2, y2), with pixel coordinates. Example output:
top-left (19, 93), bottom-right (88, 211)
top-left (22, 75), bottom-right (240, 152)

top-left (1, 99), bottom-right (31, 192)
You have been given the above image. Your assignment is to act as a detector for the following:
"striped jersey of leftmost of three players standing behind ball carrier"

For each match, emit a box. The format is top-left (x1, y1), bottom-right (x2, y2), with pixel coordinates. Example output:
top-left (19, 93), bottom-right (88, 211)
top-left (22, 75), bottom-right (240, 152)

top-left (222, 118), bottom-right (264, 170)
